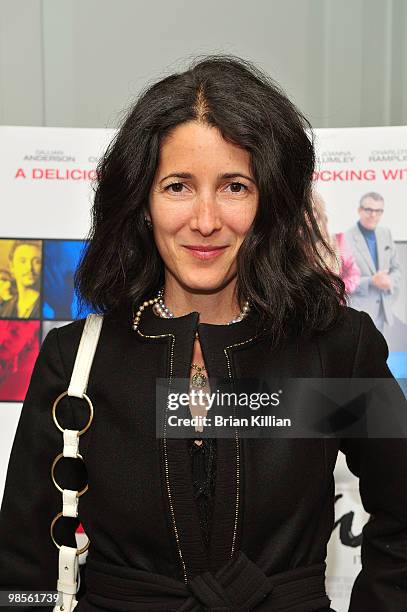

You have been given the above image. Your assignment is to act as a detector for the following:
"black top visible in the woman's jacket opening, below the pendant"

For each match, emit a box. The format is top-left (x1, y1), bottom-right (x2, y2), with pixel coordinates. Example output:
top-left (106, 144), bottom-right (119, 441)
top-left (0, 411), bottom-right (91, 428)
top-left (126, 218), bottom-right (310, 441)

top-left (189, 438), bottom-right (216, 547)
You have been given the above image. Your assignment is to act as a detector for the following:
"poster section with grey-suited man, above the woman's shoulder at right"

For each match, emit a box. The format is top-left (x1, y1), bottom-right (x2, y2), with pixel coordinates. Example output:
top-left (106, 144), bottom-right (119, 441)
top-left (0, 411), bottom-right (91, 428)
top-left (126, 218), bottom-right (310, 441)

top-left (315, 127), bottom-right (407, 378)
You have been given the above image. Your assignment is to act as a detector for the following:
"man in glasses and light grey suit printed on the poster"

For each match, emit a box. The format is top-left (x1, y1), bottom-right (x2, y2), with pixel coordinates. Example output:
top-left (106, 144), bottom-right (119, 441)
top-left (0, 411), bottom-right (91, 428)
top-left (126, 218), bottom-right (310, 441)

top-left (346, 192), bottom-right (401, 333)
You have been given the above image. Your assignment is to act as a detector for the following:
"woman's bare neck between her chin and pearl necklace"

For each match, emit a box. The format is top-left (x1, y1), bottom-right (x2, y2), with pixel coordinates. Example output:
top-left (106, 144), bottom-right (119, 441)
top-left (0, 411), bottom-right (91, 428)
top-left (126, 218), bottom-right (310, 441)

top-left (164, 280), bottom-right (241, 325)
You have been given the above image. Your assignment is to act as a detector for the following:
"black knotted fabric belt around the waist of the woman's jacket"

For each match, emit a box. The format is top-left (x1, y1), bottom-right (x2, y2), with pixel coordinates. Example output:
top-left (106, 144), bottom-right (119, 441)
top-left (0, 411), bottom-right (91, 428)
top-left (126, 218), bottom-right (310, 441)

top-left (80, 551), bottom-right (330, 612)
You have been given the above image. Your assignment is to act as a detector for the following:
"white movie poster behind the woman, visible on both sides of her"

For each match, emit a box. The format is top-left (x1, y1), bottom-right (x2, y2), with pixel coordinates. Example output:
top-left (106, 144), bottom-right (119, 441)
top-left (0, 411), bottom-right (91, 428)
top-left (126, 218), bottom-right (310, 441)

top-left (0, 127), bottom-right (407, 612)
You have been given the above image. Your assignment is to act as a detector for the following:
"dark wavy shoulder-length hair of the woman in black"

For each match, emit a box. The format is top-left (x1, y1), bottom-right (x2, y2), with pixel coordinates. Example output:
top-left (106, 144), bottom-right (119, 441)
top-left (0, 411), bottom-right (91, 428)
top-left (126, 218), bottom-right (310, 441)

top-left (75, 54), bottom-right (345, 344)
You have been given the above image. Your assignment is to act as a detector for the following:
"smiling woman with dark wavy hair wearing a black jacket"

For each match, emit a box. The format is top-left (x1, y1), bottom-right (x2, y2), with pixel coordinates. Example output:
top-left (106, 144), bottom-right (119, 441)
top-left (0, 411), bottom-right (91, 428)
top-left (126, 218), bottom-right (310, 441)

top-left (0, 56), bottom-right (407, 612)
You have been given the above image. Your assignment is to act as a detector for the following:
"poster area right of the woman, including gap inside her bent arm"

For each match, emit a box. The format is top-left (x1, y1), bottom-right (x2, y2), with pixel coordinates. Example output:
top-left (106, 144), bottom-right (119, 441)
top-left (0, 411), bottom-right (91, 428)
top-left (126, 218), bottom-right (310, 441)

top-left (315, 127), bottom-right (407, 612)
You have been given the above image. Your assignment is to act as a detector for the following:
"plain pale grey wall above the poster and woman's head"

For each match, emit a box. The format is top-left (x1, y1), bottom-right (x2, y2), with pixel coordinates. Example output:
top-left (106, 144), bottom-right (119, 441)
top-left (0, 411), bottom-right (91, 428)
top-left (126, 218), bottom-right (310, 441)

top-left (0, 0), bottom-right (407, 127)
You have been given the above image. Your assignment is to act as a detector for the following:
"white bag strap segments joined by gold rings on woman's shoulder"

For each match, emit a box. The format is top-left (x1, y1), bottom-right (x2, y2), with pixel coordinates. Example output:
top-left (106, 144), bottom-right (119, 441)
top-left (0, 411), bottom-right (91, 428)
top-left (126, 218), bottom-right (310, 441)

top-left (53, 314), bottom-right (103, 612)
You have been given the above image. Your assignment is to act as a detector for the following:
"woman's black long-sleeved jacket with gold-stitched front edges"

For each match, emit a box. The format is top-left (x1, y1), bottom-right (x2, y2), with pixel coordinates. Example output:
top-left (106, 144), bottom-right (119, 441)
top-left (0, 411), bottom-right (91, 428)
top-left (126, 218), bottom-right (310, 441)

top-left (0, 306), bottom-right (407, 612)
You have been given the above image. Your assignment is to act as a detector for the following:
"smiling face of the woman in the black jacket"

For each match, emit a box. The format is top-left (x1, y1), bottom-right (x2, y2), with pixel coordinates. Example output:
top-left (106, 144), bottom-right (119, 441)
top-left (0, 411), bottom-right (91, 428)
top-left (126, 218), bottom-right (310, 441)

top-left (149, 121), bottom-right (258, 292)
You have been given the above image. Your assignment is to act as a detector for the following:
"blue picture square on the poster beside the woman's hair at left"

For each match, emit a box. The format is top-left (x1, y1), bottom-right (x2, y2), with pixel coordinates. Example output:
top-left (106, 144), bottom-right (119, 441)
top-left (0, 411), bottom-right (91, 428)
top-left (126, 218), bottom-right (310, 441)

top-left (42, 240), bottom-right (92, 320)
